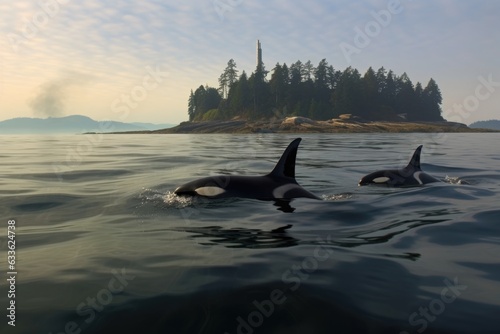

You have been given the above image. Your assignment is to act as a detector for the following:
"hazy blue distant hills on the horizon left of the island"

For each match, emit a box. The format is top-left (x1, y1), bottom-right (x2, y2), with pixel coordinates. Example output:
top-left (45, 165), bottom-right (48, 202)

top-left (0, 115), bottom-right (174, 134)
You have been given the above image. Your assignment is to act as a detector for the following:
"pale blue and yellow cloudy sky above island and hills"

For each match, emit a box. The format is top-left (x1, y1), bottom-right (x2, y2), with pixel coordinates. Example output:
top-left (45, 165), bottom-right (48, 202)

top-left (0, 0), bottom-right (500, 124)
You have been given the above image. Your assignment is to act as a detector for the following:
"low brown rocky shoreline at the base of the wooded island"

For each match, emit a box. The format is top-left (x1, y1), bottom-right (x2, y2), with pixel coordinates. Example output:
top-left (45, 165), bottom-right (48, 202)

top-left (109, 117), bottom-right (496, 134)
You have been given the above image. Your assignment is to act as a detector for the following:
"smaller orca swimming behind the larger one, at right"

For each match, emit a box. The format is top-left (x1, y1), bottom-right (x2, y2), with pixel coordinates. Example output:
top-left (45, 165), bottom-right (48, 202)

top-left (358, 145), bottom-right (440, 187)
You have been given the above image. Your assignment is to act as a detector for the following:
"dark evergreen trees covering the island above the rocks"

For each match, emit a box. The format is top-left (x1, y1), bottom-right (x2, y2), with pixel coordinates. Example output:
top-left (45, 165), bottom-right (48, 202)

top-left (188, 59), bottom-right (443, 121)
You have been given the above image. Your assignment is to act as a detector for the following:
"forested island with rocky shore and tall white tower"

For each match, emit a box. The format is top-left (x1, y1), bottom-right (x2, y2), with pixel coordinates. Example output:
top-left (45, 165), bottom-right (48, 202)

top-left (112, 41), bottom-right (496, 134)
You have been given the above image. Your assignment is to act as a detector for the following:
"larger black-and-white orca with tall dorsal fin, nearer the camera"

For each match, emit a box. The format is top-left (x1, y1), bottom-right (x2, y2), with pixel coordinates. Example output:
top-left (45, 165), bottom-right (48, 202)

top-left (174, 138), bottom-right (320, 201)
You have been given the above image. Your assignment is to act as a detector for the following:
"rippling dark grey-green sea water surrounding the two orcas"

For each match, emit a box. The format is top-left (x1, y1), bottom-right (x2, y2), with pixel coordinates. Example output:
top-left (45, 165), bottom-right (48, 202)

top-left (0, 134), bottom-right (500, 334)
